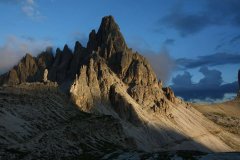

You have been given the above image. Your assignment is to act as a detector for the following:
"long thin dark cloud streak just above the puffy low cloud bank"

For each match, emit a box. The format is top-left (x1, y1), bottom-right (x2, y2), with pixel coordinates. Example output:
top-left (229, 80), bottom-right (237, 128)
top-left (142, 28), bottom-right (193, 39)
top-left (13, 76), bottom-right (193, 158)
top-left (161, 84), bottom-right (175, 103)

top-left (176, 53), bottom-right (240, 68)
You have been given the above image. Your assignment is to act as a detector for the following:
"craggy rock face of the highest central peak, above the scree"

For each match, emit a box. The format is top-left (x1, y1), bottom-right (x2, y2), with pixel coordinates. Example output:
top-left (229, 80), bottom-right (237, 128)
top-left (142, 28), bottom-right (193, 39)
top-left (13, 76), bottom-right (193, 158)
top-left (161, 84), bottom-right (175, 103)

top-left (71, 16), bottom-right (169, 115)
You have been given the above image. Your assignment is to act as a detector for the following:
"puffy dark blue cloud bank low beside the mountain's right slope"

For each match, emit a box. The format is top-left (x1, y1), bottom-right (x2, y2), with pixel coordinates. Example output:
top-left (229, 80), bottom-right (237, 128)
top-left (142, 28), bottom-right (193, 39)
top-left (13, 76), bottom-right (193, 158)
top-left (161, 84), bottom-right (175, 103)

top-left (171, 67), bottom-right (238, 101)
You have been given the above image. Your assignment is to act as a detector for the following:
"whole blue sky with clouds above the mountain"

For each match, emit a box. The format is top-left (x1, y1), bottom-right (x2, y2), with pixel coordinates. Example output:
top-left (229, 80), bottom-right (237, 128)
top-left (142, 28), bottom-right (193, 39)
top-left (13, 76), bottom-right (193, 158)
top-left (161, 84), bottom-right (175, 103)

top-left (0, 0), bottom-right (240, 102)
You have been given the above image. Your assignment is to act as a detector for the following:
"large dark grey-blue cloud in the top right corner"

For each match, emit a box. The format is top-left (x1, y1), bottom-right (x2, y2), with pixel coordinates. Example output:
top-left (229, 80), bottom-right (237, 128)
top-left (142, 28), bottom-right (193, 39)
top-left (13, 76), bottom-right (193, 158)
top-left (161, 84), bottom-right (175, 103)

top-left (158, 0), bottom-right (240, 36)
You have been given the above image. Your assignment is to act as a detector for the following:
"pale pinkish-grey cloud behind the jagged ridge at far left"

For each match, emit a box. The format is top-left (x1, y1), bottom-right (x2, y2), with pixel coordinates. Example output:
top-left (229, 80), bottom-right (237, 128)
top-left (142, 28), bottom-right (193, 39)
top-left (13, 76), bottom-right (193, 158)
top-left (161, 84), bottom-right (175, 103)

top-left (0, 36), bottom-right (51, 74)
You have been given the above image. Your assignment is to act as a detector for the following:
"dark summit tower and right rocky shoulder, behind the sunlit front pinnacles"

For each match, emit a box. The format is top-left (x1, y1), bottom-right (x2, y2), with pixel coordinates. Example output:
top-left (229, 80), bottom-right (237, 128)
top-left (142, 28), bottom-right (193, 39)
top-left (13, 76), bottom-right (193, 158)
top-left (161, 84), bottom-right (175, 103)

top-left (81, 16), bottom-right (168, 112)
